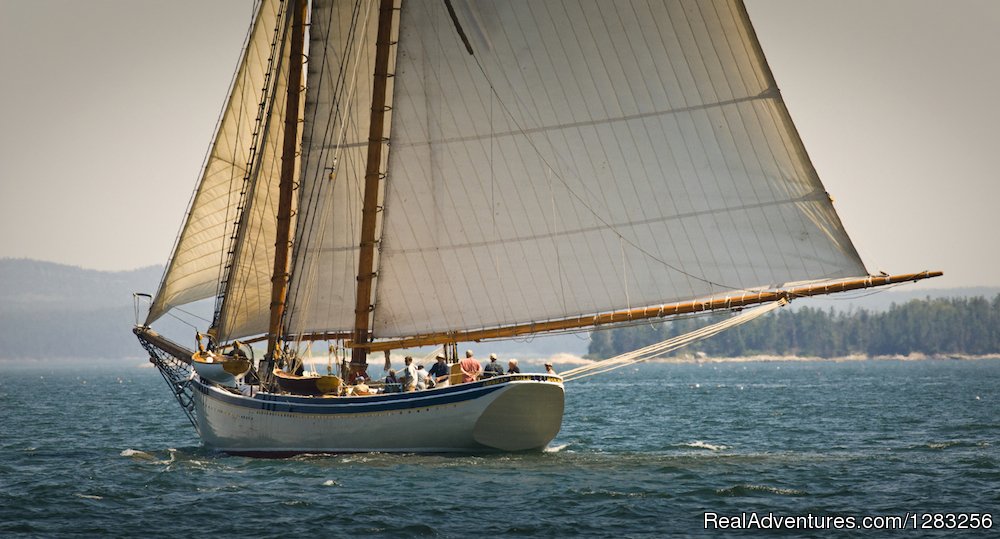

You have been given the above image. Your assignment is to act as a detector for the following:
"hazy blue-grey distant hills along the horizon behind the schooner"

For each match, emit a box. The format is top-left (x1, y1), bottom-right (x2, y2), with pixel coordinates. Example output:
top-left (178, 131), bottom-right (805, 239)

top-left (0, 258), bottom-right (1000, 359)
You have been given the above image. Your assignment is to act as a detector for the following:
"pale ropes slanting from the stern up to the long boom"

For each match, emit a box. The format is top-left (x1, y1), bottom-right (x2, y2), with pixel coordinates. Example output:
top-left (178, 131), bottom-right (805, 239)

top-left (562, 299), bottom-right (788, 382)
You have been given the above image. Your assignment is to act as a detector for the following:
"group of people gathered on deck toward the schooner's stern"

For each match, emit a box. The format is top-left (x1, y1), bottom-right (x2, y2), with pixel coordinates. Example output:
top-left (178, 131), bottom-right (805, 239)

top-left (385, 350), bottom-right (555, 391)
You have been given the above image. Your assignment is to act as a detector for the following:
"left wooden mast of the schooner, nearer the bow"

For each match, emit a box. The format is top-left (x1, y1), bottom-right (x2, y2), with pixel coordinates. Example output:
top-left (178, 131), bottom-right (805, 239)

top-left (265, 0), bottom-right (308, 362)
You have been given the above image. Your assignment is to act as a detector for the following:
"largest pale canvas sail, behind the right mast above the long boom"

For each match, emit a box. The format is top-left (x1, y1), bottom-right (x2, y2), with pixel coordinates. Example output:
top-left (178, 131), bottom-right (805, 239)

top-left (370, 0), bottom-right (867, 337)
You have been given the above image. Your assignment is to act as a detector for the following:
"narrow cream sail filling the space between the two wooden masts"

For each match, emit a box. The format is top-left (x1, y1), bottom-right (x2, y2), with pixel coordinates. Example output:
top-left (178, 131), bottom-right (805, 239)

top-left (285, 0), bottom-right (379, 334)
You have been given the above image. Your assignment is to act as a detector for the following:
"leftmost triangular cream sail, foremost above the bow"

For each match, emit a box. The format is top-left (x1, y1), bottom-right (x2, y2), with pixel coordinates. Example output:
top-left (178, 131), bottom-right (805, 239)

top-left (146, 0), bottom-right (290, 325)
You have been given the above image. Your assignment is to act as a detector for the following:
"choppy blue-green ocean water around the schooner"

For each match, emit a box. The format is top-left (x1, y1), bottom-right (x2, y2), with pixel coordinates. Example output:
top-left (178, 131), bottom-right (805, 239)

top-left (0, 360), bottom-right (1000, 537)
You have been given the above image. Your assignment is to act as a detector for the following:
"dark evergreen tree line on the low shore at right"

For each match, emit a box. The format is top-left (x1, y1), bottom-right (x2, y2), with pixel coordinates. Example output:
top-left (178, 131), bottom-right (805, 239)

top-left (589, 295), bottom-right (1000, 358)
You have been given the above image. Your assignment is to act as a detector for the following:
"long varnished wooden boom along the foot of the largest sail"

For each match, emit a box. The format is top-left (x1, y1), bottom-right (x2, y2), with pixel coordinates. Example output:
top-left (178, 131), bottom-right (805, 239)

top-left (345, 271), bottom-right (943, 352)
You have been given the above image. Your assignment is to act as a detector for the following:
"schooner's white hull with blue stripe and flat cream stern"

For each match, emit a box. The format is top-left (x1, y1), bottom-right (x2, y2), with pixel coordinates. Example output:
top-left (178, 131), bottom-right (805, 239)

top-left (188, 375), bottom-right (564, 456)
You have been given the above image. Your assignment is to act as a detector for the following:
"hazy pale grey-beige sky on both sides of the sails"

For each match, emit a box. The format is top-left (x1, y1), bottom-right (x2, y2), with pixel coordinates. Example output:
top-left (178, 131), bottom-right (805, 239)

top-left (0, 0), bottom-right (1000, 287)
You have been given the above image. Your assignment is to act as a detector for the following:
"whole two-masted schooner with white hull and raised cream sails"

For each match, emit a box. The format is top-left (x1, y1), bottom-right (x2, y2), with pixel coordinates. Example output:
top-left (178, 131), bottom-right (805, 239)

top-left (134, 0), bottom-right (940, 455)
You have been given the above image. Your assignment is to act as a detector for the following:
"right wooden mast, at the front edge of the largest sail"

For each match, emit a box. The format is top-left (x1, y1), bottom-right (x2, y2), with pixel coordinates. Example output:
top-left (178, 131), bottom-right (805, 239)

top-left (351, 0), bottom-right (395, 366)
